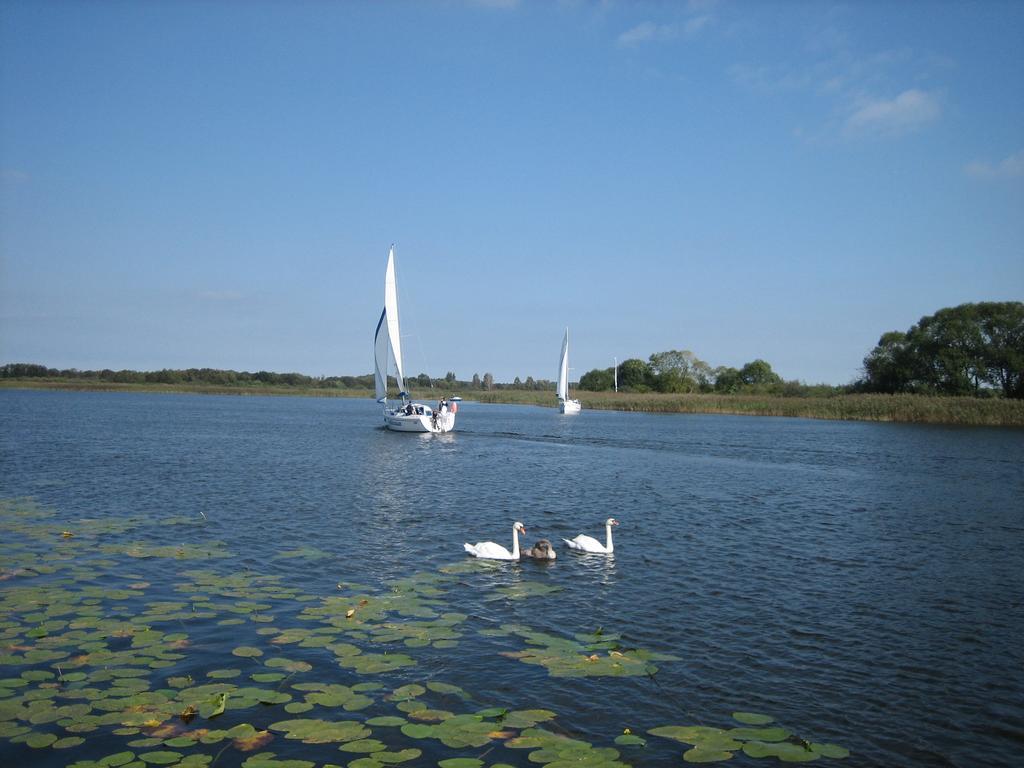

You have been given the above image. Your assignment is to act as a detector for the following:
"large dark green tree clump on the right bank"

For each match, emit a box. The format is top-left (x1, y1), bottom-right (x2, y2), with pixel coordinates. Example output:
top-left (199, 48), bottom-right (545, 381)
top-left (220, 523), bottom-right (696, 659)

top-left (858, 301), bottom-right (1024, 398)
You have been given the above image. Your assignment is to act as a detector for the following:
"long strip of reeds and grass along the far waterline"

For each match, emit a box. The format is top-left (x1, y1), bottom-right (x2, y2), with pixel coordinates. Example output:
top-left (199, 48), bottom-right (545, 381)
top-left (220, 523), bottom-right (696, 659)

top-left (0, 378), bottom-right (1024, 427)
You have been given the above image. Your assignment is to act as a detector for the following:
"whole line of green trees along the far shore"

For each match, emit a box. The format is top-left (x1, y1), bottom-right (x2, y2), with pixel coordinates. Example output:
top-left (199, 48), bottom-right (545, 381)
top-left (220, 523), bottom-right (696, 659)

top-left (6, 301), bottom-right (1024, 398)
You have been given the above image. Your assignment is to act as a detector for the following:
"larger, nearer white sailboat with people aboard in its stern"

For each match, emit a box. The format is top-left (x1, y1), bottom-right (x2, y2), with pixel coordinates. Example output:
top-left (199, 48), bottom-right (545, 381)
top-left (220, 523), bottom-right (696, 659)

top-left (374, 246), bottom-right (462, 432)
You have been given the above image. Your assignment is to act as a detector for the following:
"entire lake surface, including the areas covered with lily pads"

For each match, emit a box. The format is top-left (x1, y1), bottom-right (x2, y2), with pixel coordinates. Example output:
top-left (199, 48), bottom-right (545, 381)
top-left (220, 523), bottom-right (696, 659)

top-left (0, 391), bottom-right (1024, 768)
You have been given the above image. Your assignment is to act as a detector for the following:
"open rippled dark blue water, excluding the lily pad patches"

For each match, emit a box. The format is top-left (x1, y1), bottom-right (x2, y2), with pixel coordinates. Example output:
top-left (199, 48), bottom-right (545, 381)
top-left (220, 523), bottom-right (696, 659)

top-left (0, 391), bottom-right (1024, 766)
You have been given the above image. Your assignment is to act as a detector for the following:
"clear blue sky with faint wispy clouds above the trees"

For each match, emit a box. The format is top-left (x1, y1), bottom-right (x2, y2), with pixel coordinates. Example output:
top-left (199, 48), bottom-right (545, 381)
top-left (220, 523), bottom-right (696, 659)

top-left (0, 0), bottom-right (1024, 384)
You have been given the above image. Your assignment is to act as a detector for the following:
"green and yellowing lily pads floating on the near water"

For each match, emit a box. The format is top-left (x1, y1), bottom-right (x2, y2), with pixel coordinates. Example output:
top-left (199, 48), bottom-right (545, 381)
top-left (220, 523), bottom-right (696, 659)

top-left (0, 502), bottom-right (848, 768)
